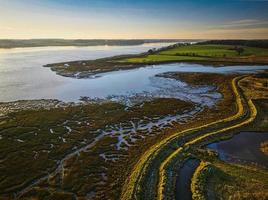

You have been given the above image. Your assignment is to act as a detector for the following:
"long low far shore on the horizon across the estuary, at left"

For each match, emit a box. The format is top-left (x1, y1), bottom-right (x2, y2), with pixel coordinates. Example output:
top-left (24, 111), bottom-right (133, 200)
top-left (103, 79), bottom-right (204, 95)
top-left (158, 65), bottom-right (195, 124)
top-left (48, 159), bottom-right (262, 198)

top-left (0, 39), bottom-right (198, 48)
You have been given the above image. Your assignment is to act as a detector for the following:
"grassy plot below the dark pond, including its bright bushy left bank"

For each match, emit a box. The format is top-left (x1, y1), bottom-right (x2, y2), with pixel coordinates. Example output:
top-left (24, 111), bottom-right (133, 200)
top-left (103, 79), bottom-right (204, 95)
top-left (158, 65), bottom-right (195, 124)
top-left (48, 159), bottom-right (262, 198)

top-left (191, 145), bottom-right (268, 200)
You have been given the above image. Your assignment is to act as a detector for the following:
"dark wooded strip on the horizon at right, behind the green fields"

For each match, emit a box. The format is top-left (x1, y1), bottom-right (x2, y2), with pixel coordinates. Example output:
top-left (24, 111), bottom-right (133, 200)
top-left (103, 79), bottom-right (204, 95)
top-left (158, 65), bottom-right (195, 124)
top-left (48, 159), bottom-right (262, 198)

top-left (198, 40), bottom-right (268, 48)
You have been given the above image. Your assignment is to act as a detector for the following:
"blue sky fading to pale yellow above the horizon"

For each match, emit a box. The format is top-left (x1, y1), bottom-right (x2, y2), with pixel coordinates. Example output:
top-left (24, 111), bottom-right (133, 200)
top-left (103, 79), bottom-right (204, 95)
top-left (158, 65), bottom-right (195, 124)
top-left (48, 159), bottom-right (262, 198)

top-left (0, 0), bottom-right (268, 39)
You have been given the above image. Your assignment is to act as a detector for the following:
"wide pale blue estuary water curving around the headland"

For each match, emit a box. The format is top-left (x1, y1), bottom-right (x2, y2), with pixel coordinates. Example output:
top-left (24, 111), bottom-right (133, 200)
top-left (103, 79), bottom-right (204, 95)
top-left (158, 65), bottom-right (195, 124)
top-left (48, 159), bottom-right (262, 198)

top-left (0, 44), bottom-right (268, 103)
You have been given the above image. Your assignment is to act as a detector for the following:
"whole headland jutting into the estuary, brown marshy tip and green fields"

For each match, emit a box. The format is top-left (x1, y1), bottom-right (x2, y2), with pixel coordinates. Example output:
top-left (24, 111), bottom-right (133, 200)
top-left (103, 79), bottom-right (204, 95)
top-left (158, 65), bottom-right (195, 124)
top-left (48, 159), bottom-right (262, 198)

top-left (45, 43), bottom-right (268, 78)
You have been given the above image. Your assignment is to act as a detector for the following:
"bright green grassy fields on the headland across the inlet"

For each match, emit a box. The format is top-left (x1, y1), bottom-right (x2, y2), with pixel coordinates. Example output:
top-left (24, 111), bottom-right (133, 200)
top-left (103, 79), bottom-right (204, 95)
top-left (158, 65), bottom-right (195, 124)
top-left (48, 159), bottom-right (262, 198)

top-left (122, 45), bottom-right (268, 63)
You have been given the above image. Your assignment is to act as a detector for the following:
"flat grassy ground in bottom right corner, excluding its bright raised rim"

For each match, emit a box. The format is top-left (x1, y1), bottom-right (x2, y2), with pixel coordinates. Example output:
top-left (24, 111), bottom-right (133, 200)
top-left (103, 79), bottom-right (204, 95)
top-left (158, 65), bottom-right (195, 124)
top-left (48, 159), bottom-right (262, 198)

top-left (206, 161), bottom-right (268, 200)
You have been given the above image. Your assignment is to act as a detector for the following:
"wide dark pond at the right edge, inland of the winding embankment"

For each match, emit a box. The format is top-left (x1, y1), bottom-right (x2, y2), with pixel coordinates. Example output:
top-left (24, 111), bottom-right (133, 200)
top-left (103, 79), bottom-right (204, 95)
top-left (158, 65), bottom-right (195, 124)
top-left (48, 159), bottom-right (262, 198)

top-left (207, 132), bottom-right (268, 168)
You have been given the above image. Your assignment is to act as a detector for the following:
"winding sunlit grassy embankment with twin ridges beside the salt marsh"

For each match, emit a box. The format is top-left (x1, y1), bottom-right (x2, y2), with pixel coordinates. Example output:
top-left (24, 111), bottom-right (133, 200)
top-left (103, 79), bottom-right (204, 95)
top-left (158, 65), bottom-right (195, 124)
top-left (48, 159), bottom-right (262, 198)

top-left (121, 76), bottom-right (257, 200)
